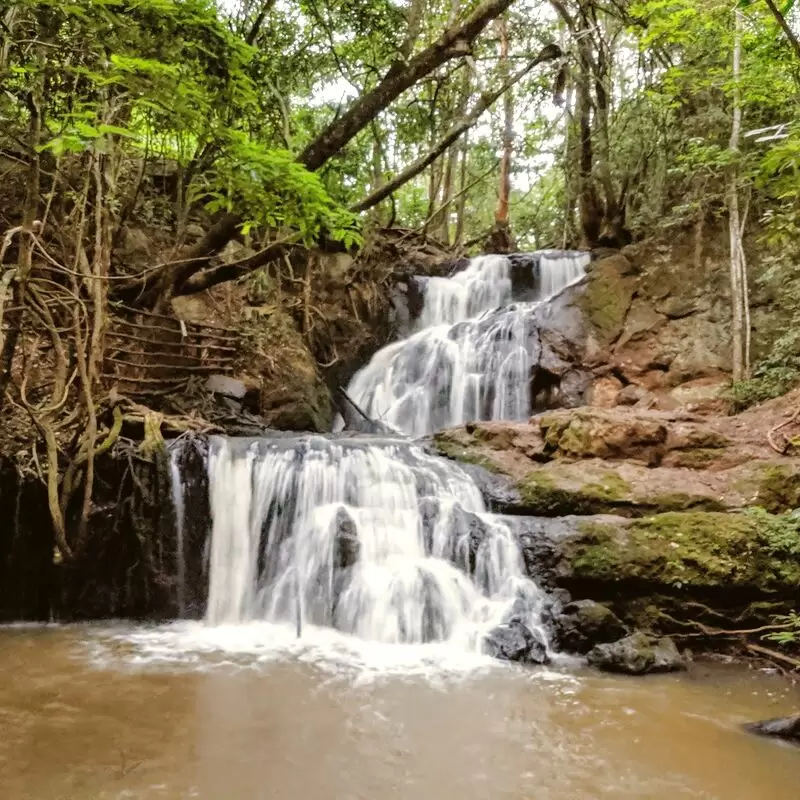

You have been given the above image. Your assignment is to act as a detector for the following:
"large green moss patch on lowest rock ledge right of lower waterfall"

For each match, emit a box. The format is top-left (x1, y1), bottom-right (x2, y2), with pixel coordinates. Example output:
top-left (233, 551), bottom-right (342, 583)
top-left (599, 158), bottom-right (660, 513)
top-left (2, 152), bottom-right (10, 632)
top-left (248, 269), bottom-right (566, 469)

top-left (570, 512), bottom-right (800, 591)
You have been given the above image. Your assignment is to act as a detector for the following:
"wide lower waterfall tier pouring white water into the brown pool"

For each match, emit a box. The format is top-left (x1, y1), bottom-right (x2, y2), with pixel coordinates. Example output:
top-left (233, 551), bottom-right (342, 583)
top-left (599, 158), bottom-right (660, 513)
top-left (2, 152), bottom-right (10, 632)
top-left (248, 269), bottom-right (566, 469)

top-left (206, 436), bottom-right (546, 651)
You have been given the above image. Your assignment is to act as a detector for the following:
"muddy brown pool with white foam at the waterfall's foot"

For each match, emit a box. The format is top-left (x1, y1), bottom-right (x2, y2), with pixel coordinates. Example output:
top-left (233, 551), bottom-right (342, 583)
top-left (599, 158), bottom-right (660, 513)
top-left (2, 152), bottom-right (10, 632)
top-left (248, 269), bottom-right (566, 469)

top-left (0, 625), bottom-right (800, 800)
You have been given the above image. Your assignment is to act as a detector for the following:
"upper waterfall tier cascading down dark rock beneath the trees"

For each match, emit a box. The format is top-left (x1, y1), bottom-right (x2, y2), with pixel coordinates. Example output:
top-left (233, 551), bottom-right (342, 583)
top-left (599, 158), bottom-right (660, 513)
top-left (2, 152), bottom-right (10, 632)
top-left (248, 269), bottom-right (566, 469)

top-left (338, 251), bottom-right (589, 436)
